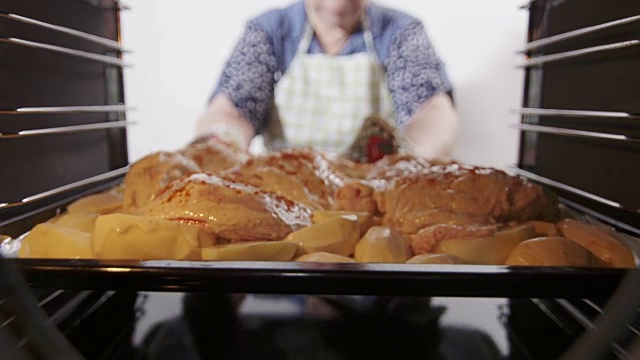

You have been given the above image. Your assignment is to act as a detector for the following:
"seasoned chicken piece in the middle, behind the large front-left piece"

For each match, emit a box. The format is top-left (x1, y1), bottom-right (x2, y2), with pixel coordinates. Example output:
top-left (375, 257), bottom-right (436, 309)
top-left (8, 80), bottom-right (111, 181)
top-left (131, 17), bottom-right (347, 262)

top-left (222, 149), bottom-right (348, 209)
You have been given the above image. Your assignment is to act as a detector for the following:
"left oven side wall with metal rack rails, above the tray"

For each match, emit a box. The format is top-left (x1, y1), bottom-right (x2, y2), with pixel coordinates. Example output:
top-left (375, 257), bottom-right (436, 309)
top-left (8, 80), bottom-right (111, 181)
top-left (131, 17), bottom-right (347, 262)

top-left (0, 0), bottom-right (135, 222)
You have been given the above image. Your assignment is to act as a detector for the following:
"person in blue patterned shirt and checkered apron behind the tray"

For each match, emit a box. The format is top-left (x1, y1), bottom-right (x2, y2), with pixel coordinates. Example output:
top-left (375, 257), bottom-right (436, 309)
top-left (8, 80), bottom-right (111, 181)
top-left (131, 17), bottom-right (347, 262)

top-left (195, 0), bottom-right (459, 159)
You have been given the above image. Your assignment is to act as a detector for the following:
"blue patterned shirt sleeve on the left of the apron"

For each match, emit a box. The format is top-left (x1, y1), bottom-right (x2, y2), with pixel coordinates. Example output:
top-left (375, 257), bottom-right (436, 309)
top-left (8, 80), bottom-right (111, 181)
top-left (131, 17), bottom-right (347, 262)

top-left (213, 21), bottom-right (278, 132)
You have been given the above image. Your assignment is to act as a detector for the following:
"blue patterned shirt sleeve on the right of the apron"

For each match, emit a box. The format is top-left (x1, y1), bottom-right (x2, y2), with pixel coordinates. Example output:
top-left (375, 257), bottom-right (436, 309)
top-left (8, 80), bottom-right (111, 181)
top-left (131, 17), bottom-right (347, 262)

top-left (385, 20), bottom-right (451, 127)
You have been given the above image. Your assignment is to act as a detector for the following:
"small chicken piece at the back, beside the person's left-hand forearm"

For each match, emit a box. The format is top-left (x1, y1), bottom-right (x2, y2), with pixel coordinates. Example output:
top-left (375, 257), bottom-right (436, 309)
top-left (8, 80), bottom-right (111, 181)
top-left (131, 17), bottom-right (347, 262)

top-left (178, 141), bottom-right (250, 173)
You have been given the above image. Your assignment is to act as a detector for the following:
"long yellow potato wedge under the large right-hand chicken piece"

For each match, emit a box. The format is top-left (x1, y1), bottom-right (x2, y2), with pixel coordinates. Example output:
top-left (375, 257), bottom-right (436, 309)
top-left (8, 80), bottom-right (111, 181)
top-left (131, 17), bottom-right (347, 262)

top-left (434, 224), bottom-right (536, 265)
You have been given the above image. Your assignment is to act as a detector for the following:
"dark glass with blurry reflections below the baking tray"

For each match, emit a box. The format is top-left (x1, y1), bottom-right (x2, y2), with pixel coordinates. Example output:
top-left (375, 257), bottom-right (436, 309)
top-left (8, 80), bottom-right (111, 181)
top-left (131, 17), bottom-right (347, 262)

top-left (133, 293), bottom-right (510, 360)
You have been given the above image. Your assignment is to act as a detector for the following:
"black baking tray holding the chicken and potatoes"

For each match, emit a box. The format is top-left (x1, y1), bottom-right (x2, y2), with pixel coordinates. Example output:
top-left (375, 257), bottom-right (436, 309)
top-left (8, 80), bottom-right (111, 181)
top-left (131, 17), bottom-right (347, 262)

top-left (0, 181), bottom-right (640, 299)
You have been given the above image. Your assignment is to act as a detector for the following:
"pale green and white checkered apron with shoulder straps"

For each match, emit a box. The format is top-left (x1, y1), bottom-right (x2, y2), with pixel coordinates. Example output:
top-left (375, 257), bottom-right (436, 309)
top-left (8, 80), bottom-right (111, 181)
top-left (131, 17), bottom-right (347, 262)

top-left (265, 15), bottom-right (393, 154)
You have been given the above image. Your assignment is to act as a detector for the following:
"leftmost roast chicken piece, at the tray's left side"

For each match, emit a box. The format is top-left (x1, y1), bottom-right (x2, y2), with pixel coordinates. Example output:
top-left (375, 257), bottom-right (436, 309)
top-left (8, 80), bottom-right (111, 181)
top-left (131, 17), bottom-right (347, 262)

top-left (122, 151), bottom-right (200, 212)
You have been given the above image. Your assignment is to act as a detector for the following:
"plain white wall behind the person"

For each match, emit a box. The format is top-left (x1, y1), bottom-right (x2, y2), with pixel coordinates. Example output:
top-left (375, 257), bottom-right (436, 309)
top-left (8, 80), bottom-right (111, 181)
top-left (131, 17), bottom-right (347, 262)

top-left (122, 0), bottom-right (527, 168)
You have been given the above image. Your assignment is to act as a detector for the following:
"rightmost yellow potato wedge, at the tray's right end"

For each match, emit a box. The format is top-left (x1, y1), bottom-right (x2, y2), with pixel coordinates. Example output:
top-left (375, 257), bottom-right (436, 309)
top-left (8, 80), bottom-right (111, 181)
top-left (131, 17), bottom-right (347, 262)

top-left (556, 219), bottom-right (636, 268)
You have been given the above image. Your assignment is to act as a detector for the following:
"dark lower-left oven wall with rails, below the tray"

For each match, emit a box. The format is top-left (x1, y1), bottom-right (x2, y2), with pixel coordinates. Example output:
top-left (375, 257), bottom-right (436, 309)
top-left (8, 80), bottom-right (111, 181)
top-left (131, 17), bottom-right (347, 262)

top-left (0, 261), bottom-right (146, 359)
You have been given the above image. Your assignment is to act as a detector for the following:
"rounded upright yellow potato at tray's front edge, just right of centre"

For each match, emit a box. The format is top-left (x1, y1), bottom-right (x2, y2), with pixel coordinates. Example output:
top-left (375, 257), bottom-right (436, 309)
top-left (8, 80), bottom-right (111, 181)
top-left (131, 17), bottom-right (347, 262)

top-left (354, 226), bottom-right (413, 263)
